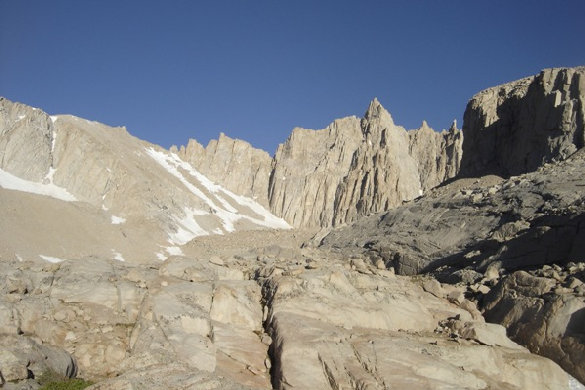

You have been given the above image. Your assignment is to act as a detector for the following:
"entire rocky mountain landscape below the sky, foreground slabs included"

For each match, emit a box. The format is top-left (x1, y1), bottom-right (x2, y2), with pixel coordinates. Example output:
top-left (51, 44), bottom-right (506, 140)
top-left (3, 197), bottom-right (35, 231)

top-left (0, 67), bottom-right (585, 390)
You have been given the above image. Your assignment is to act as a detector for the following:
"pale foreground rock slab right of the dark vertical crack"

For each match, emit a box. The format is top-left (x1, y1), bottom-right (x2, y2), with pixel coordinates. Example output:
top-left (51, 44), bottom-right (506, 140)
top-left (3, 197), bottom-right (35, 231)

top-left (264, 258), bottom-right (569, 389)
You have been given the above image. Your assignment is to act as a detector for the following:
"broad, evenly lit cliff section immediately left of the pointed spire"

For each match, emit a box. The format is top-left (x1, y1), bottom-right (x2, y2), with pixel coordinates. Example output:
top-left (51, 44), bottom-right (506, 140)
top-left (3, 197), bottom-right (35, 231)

top-left (268, 117), bottom-right (362, 227)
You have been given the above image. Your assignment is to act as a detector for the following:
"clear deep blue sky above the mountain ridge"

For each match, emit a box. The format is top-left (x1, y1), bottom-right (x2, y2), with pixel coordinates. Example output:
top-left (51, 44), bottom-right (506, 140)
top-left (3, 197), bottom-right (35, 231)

top-left (0, 0), bottom-right (585, 153)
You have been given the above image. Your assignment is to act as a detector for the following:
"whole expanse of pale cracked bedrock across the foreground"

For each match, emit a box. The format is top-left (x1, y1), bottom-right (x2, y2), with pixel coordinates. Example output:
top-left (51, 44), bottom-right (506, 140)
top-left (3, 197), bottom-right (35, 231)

top-left (0, 232), bottom-right (570, 389)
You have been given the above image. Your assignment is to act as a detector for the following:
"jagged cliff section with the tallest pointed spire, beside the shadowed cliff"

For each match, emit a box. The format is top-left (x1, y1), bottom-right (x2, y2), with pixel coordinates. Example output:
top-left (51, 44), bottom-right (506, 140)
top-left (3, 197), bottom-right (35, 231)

top-left (333, 100), bottom-right (462, 225)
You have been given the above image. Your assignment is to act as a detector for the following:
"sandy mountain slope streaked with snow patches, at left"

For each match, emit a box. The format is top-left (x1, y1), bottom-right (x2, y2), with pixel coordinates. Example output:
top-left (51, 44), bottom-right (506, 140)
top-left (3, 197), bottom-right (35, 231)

top-left (0, 99), bottom-right (289, 261)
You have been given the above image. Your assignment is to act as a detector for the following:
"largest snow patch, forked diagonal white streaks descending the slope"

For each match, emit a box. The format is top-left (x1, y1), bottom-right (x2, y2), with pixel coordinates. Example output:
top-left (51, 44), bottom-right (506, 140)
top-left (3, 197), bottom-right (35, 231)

top-left (146, 147), bottom-right (291, 245)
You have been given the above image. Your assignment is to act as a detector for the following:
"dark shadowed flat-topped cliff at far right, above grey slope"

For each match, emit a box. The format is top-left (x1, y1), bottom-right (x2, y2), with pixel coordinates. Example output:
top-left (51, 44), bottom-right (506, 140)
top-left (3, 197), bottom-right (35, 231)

top-left (461, 67), bottom-right (585, 176)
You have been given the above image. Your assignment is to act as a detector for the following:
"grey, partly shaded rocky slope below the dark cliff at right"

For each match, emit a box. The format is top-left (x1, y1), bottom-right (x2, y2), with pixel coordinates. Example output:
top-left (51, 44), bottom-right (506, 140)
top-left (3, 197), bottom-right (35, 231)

top-left (322, 141), bottom-right (585, 381)
